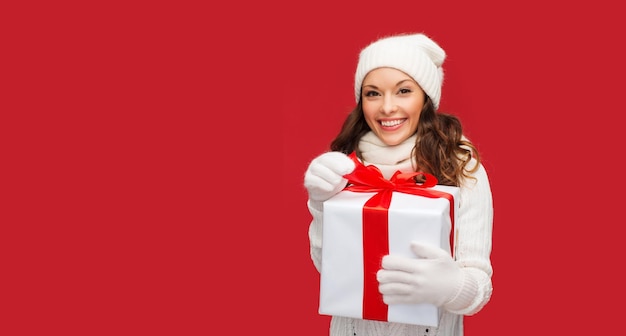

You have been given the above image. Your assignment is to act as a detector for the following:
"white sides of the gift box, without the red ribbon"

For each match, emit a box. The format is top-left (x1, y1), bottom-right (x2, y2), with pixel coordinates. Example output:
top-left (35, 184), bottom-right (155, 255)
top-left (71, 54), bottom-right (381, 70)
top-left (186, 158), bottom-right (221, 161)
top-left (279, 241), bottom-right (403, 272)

top-left (319, 185), bottom-right (460, 327)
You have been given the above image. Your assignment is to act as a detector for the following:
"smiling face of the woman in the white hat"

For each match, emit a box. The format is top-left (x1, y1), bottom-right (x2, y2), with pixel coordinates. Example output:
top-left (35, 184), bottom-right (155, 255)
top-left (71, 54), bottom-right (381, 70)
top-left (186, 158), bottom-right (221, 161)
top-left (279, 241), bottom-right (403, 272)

top-left (361, 68), bottom-right (426, 146)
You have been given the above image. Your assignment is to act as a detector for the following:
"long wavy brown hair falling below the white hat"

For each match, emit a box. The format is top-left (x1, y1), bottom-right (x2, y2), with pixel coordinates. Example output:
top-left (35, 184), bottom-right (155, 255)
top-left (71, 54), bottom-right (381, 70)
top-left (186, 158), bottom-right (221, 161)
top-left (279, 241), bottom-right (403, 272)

top-left (330, 96), bottom-right (480, 186)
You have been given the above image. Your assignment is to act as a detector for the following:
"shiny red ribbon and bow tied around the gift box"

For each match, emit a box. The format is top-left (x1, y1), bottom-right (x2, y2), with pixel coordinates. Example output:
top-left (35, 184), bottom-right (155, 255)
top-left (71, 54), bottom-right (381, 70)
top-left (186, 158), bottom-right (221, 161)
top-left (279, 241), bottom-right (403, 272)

top-left (344, 152), bottom-right (454, 321)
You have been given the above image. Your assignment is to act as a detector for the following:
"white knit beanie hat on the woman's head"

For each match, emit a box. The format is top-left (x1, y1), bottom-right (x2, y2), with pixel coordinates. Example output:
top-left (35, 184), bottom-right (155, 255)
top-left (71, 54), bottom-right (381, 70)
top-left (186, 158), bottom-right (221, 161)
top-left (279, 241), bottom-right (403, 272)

top-left (354, 34), bottom-right (446, 110)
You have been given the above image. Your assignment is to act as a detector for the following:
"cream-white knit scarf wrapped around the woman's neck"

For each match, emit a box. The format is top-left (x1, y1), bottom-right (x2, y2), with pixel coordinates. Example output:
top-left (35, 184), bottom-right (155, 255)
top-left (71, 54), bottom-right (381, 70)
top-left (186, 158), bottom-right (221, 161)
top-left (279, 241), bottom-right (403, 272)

top-left (359, 131), bottom-right (417, 179)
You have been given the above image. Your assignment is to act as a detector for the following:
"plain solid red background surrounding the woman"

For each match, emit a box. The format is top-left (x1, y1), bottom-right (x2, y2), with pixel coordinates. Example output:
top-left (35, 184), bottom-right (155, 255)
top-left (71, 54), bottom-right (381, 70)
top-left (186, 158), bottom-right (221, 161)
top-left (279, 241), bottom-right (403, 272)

top-left (0, 1), bottom-right (626, 335)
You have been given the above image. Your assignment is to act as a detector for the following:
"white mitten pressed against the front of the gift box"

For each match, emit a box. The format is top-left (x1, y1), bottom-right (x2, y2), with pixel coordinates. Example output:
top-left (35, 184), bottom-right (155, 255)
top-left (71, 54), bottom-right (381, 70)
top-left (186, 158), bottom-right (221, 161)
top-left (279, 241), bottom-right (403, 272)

top-left (377, 243), bottom-right (463, 307)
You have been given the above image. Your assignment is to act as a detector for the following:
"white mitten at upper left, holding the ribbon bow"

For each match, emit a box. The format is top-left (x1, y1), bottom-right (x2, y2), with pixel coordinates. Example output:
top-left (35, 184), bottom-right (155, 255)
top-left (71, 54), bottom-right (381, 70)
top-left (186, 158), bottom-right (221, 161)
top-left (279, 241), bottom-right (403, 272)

top-left (304, 152), bottom-right (356, 202)
